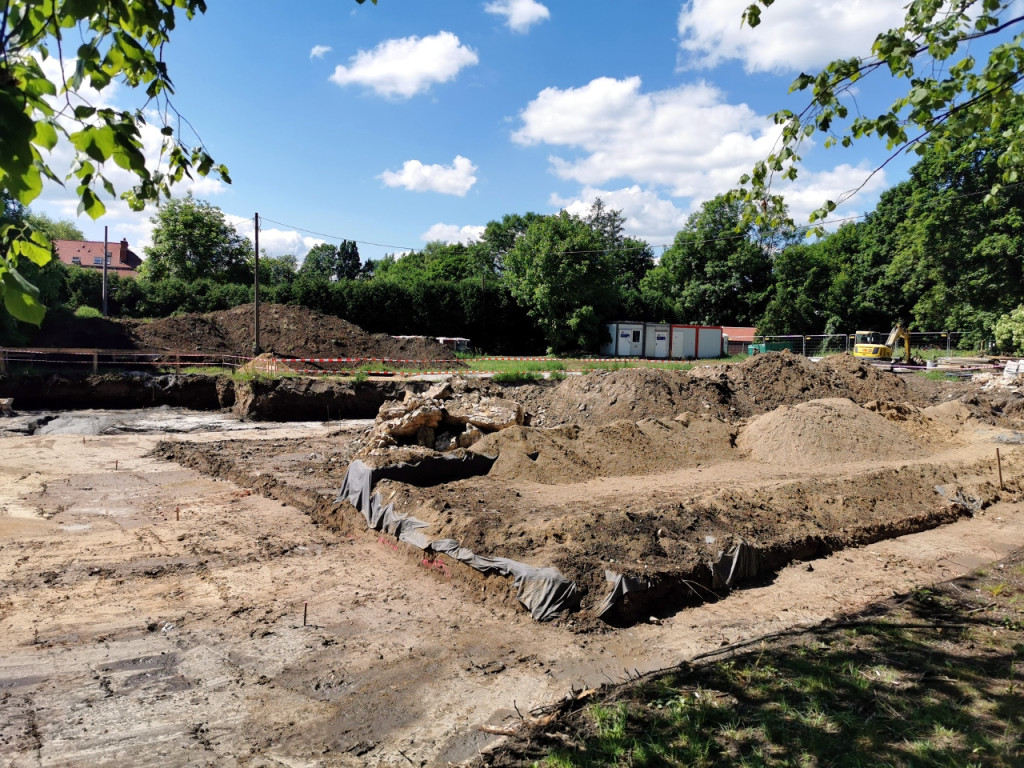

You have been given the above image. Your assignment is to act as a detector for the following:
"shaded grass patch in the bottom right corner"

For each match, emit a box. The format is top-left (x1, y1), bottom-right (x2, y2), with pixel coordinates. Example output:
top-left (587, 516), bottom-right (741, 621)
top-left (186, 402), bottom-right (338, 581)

top-left (490, 551), bottom-right (1024, 768)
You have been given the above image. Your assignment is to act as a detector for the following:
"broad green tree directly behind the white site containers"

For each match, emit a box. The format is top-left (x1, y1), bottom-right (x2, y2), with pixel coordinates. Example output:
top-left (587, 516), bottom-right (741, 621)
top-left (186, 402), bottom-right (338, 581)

top-left (640, 195), bottom-right (772, 326)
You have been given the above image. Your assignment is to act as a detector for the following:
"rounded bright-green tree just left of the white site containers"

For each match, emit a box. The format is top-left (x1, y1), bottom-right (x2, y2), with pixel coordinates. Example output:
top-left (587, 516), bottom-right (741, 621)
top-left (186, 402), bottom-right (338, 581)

top-left (502, 211), bottom-right (616, 351)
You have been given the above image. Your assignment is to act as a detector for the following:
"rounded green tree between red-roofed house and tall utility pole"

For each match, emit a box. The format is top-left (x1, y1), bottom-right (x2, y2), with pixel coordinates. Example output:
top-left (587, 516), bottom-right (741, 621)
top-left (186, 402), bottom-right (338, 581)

top-left (142, 193), bottom-right (253, 283)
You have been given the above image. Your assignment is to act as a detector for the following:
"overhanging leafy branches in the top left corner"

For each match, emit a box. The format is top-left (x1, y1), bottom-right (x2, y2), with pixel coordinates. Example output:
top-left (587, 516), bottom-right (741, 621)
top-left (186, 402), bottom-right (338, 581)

top-left (0, 0), bottom-right (230, 324)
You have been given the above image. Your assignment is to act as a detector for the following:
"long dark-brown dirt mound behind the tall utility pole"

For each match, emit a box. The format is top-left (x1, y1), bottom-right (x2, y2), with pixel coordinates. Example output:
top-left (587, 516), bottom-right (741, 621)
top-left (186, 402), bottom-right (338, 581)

top-left (125, 304), bottom-right (453, 361)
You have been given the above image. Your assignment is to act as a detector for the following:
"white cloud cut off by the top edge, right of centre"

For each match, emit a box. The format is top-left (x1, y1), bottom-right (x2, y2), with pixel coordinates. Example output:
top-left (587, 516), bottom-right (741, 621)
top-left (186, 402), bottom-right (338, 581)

top-left (679, 0), bottom-right (905, 72)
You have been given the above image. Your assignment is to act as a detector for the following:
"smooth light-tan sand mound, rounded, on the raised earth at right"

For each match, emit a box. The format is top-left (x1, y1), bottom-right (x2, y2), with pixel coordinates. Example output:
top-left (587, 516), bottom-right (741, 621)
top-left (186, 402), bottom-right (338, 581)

top-left (736, 397), bottom-right (925, 467)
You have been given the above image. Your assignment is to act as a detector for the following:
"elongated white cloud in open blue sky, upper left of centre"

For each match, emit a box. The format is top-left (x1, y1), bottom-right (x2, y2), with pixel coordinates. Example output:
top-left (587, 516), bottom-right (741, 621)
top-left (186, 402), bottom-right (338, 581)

top-left (331, 32), bottom-right (479, 98)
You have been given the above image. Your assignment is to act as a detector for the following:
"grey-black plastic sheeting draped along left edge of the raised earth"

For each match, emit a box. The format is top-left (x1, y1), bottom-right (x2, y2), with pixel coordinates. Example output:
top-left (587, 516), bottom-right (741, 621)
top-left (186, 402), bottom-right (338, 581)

top-left (336, 454), bottom-right (580, 622)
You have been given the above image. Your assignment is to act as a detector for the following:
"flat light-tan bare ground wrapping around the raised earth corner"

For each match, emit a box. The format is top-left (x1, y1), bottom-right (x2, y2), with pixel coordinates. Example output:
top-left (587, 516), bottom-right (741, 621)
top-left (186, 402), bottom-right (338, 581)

top-left (6, 425), bottom-right (1024, 767)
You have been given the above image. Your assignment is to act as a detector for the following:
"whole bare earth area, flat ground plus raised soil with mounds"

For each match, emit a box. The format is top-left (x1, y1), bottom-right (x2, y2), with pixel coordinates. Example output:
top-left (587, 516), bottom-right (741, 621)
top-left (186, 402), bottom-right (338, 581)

top-left (0, 346), bottom-right (1024, 766)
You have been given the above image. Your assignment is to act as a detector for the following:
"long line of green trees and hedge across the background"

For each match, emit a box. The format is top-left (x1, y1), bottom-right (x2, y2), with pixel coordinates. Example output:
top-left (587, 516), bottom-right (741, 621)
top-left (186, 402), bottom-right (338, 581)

top-left (2, 105), bottom-right (1024, 353)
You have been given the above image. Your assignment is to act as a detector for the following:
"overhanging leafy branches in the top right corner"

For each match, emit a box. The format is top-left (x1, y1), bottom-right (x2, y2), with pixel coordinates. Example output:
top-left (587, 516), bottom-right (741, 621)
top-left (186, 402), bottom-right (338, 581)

top-left (741, 0), bottom-right (1024, 227)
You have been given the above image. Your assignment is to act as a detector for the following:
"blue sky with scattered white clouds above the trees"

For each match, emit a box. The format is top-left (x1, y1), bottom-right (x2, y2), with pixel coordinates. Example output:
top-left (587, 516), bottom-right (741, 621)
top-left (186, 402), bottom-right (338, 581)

top-left (33, 0), bottom-right (983, 258)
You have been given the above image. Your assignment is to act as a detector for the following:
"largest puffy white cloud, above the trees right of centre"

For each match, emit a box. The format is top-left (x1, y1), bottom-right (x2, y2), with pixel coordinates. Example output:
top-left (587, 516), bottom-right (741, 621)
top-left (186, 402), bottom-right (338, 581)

top-left (512, 77), bottom-right (778, 197)
